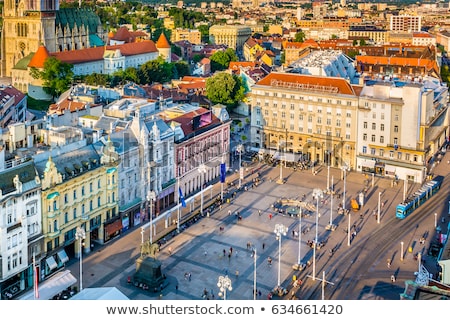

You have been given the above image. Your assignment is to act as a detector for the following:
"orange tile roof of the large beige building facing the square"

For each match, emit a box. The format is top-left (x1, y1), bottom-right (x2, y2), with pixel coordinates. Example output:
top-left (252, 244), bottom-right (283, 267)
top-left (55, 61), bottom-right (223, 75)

top-left (256, 72), bottom-right (355, 95)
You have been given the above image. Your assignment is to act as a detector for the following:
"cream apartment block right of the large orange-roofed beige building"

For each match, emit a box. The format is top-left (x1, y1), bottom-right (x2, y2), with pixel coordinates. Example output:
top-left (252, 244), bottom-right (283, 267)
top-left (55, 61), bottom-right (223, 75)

top-left (356, 77), bottom-right (449, 183)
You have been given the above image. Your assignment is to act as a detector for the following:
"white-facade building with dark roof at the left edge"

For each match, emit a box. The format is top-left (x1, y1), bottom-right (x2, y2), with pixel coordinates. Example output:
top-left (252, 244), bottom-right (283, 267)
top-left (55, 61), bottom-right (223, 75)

top-left (0, 160), bottom-right (42, 299)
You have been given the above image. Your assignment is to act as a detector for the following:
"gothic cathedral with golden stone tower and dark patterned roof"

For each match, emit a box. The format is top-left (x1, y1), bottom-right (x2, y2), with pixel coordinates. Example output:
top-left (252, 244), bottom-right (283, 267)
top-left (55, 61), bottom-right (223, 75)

top-left (1, 0), bottom-right (107, 77)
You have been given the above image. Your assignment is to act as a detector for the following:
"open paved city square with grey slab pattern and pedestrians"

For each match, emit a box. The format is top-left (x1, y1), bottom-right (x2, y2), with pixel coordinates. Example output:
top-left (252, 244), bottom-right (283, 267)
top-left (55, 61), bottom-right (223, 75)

top-left (68, 155), bottom-right (448, 300)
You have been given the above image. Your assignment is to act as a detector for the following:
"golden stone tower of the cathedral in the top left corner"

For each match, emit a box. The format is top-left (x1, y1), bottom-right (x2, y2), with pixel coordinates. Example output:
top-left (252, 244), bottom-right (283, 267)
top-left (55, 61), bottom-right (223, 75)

top-left (1, 0), bottom-right (59, 77)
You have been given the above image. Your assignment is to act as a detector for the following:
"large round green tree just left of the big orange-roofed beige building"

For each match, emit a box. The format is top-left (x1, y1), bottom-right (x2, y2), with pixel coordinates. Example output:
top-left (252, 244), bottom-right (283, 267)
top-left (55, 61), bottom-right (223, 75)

top-left (206, 72), bottom-right (244, 111)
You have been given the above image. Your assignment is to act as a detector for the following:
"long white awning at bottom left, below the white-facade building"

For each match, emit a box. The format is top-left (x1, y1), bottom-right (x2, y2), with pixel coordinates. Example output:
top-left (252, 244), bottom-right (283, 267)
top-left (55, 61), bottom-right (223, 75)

top-left (19, 270), bottom-right (77, 300)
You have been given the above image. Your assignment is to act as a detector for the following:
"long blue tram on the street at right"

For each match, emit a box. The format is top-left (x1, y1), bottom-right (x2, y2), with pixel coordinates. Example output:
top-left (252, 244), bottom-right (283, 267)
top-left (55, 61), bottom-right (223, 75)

top-left (395, 176), bottom-right (444, 219)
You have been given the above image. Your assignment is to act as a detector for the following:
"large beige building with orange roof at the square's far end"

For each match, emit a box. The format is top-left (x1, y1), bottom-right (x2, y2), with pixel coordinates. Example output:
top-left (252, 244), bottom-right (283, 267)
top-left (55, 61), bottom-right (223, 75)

top-left (250, 72), bottom-right (358, 168)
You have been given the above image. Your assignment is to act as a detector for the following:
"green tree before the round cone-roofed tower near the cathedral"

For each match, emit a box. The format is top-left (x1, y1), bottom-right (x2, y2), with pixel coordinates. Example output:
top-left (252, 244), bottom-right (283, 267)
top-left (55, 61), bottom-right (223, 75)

top-left (30, 57), bottom-right (74, 100)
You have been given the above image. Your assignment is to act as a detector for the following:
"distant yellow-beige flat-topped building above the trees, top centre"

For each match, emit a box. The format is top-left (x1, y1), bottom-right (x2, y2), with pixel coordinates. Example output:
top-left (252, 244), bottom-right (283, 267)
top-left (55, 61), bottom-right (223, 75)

top-left (209, 25), bottom-right (252, 53)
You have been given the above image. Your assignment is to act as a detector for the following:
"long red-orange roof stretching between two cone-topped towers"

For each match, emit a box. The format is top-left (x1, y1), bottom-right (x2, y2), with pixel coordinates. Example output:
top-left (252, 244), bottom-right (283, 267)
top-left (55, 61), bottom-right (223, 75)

top-left (50, 40), bottom-right (158, 64)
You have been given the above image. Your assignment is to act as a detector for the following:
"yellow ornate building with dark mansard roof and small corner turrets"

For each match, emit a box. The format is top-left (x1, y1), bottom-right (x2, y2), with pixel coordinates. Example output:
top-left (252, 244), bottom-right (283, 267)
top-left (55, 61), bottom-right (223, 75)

top-left (36, 142), bottom-right (122, 275)
